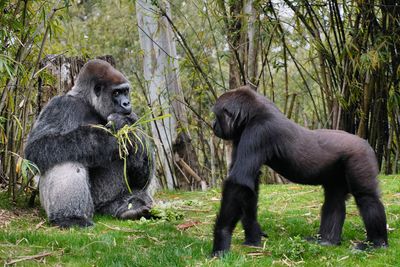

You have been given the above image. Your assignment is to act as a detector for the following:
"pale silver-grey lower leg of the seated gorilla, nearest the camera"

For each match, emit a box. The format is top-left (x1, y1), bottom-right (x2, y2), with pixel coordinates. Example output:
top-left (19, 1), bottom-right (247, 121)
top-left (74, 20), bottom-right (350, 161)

top-left (39, 162), bottom-right (93, 227)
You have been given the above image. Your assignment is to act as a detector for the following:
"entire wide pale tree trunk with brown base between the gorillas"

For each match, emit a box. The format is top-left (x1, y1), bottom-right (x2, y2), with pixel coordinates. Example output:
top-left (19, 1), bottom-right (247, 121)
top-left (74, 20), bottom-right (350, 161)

top-left (136, 0), bottom-right (206, 192)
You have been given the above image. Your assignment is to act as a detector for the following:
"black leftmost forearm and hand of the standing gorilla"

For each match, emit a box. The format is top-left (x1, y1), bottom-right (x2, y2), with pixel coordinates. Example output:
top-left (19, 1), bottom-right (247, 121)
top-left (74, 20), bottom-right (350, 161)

top-left (212, 180), bottom-right (243, 256)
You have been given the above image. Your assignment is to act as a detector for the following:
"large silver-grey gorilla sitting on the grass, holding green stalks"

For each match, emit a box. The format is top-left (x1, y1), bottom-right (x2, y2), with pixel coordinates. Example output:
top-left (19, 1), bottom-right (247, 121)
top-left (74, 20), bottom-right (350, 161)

top-left (25, 60), bottom-right (153, 227)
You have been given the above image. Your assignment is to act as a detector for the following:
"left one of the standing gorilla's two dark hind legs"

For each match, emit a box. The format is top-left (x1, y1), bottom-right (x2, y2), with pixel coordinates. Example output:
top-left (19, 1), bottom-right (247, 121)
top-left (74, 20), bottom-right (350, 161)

top-left (319, 183), bottom-right (348, 245)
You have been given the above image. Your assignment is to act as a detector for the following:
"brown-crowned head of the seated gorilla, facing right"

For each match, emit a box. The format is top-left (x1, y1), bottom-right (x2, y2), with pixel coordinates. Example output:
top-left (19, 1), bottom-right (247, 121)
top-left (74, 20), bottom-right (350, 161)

top-left (68, 59), bottom-right (132, 119)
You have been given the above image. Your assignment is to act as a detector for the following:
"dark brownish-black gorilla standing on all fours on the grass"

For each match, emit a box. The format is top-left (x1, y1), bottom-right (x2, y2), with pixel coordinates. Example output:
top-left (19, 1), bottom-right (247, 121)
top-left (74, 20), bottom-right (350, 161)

top-left (212, 86), bottom-right (388, 255)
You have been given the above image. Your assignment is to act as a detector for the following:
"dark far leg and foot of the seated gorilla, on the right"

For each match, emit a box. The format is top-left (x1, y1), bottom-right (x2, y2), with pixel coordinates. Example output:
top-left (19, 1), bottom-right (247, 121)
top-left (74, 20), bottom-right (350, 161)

top-left (89, 129), bottom-right (154, 219)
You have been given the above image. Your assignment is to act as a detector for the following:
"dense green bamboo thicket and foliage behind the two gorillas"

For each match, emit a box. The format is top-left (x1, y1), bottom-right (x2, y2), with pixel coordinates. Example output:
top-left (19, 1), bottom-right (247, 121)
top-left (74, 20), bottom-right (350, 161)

top-left (0, 0), bottom-right (400, 196)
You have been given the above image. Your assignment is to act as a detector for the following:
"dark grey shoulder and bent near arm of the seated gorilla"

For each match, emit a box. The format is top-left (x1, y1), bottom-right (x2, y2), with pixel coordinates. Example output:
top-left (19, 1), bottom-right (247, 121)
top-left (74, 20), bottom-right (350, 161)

top-left (25, 96), bottom-right (118, 173)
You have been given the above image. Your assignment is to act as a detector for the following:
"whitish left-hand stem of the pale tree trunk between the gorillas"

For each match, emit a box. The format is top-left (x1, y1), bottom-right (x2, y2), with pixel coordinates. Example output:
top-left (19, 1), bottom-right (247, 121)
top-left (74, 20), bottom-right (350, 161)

top-left (136, 0), bottom-right (177, 189)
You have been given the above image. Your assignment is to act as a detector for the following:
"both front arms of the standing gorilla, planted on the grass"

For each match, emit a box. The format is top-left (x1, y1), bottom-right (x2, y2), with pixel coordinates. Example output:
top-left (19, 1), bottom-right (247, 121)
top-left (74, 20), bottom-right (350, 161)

top-left (212, 126), bottom-right (266, 256)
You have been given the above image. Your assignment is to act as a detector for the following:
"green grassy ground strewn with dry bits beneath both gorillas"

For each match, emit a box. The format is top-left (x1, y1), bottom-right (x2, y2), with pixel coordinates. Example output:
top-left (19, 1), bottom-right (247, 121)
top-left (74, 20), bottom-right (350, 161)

top-left (0, 176), bottom-right (400, 267)
